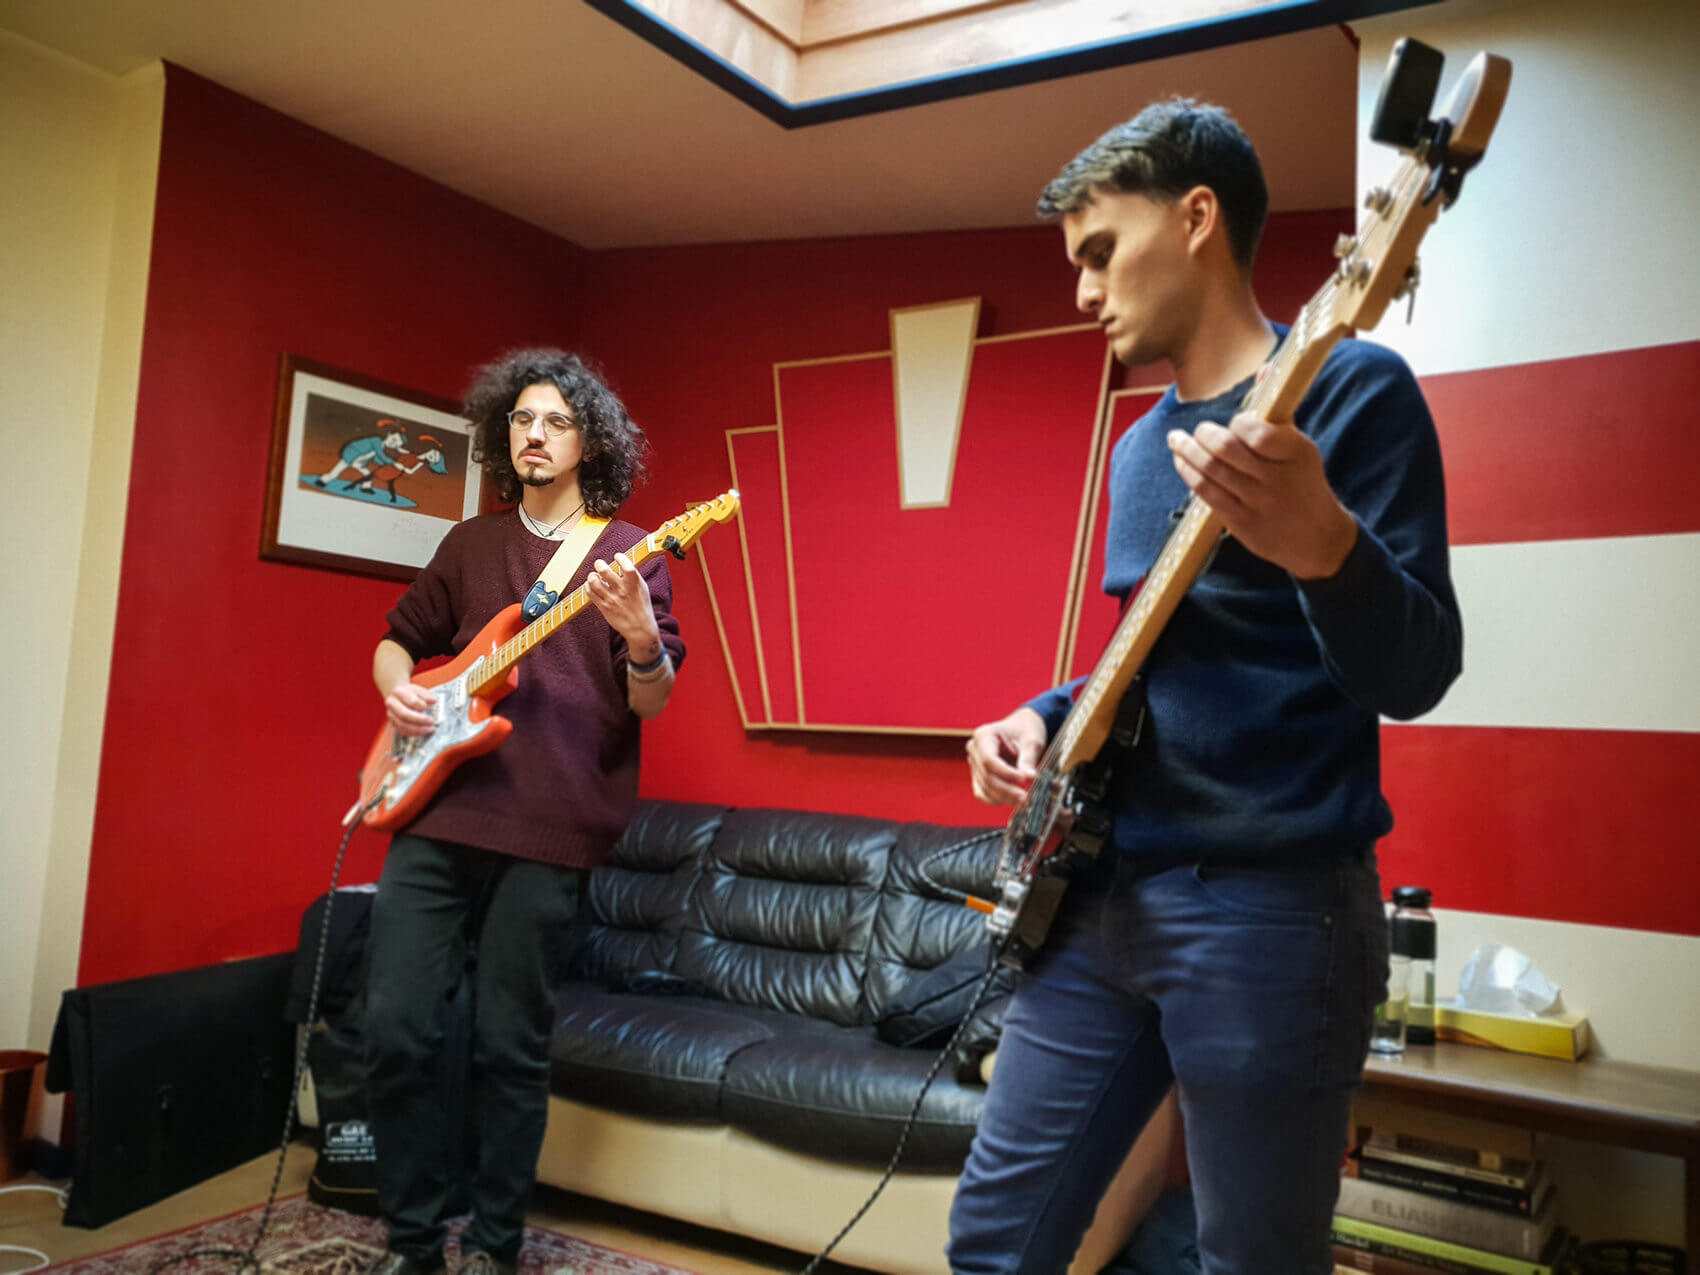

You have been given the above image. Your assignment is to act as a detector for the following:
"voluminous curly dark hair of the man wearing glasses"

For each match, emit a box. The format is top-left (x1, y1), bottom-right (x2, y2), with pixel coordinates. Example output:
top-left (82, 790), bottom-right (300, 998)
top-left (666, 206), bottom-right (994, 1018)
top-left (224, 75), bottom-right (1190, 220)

top-left (462, 350), bottom-right (649, 519)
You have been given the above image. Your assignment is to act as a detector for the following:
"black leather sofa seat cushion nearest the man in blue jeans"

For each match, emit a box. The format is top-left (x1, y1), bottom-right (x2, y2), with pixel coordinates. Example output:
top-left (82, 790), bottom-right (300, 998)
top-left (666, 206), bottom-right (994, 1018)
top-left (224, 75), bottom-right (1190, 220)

top-left (721, 1027), bottom-right (984, 1173)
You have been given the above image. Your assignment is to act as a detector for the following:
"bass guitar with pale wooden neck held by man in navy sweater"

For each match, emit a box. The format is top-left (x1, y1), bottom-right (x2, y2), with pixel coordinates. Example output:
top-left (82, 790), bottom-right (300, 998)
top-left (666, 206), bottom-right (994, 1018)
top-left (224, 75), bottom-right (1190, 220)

top-left (969, 41), bottom-right (1511, 967)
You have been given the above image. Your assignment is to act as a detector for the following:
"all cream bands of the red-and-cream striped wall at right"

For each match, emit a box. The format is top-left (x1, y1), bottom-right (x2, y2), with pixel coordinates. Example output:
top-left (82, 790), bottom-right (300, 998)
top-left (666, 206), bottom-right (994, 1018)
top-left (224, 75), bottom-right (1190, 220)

top-left (1353, 0), bottom-right (1700, 1244)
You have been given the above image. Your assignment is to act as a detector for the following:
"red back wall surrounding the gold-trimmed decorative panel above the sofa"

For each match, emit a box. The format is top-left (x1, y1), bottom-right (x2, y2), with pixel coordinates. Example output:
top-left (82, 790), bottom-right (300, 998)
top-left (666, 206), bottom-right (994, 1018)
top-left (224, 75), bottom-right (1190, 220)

top-left (587, 217), bottom-right (1352, 823)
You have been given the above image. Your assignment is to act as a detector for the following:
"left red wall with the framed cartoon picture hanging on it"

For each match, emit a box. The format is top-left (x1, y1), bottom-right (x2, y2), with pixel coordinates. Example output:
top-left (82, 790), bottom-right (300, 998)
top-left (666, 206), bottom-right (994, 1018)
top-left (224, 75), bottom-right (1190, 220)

top-left (80, 66), bottom-right (598, 983)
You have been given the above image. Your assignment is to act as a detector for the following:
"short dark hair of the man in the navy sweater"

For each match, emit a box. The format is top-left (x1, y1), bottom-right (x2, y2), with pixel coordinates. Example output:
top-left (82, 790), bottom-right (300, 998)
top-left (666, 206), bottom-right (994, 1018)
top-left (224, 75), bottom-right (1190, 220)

top-left (1039, 97), bottom-right (1270, 270)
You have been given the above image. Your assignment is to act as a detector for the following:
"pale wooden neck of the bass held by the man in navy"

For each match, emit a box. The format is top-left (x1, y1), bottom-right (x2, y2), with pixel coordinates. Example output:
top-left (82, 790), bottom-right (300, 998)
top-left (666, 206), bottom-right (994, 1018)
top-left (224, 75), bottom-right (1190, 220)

top-left (1046, 314), bottom-right (1343, 775)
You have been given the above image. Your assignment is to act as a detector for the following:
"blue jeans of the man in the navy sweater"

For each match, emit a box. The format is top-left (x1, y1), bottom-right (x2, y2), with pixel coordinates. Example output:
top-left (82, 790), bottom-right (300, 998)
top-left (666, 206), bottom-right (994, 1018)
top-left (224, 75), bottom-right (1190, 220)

top-left (949, 852), bottom-right (1387, 1275)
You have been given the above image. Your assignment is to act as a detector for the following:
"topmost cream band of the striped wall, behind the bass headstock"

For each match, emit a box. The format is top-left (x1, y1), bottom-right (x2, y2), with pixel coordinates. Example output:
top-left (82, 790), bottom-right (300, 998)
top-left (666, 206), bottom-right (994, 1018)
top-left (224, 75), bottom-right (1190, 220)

top-left (1353, 0), bottom-right (1700, 376)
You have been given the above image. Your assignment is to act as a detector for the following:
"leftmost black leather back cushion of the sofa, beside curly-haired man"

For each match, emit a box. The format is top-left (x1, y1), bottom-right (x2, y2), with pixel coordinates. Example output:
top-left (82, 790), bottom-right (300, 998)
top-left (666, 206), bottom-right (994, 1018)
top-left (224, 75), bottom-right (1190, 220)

top-left (573, 801), bottom-right (726, 988)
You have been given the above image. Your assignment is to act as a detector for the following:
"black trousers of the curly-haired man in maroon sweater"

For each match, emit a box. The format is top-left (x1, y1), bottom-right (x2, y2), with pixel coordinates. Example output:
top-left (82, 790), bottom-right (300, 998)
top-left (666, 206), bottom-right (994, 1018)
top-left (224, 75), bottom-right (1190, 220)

top-left (366, 835), bottom-right (583, 1268)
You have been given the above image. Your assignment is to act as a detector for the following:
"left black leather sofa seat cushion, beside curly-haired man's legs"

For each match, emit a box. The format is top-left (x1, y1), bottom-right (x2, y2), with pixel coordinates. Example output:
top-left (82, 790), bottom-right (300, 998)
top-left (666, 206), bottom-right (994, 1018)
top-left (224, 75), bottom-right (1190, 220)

top-left (549, 983), bottom-right (774, 1120)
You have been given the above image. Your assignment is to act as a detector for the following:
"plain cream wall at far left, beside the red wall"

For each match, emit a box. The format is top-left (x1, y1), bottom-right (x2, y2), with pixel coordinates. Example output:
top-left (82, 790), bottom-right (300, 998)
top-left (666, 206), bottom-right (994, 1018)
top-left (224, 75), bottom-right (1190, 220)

top-left (0, 31), bottom-right (165, 1049)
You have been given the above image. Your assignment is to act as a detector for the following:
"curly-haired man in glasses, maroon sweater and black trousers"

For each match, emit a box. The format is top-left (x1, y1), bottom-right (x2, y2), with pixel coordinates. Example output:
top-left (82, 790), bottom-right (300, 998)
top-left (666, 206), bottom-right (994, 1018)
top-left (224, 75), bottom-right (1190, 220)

top-left (366, 350), bottom-right (685, 1275)
